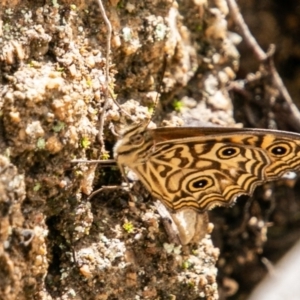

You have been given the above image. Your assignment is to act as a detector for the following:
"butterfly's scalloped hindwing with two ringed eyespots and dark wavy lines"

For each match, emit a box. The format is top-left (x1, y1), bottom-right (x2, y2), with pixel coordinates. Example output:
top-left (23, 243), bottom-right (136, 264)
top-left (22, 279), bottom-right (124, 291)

top-left (136, 138), bottom-right (270, 211)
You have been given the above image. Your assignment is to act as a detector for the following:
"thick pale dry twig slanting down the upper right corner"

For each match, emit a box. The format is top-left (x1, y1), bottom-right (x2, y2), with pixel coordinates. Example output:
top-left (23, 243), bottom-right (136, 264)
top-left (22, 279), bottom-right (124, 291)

top-left (227, 0), bottom-right (300, 131)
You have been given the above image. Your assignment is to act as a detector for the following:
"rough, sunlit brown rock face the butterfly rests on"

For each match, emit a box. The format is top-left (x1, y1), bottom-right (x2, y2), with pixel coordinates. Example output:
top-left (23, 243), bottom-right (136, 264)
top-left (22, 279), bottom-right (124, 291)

top-left (0, 0), bottom-right (297, 300)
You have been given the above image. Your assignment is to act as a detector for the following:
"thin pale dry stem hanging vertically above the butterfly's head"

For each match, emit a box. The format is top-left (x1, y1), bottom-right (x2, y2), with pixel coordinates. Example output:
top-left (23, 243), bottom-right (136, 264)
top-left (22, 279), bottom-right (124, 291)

top-left (98, 0), bottom-right (112, 153)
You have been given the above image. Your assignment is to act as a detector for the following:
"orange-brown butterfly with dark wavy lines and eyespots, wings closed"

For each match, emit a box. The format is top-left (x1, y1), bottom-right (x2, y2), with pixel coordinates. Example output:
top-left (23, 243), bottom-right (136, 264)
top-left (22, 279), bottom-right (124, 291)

top-left (114, 122), bottom-right (300, 212)
